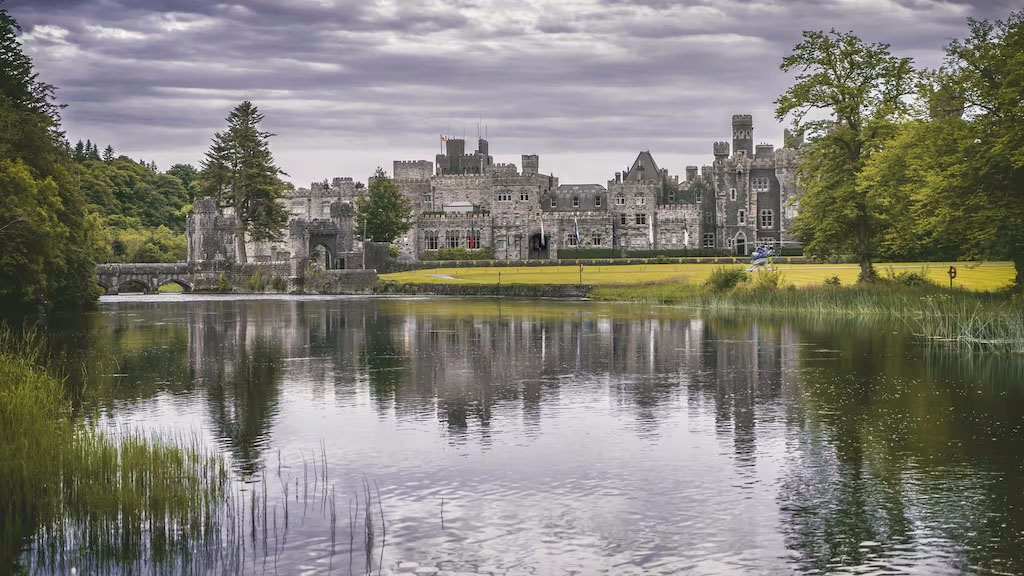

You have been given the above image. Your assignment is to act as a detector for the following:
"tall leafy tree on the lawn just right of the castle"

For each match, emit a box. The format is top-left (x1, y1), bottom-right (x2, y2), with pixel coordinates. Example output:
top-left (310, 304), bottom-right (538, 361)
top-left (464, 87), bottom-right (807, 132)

top-left (775, 30), bottom-right (915, 282)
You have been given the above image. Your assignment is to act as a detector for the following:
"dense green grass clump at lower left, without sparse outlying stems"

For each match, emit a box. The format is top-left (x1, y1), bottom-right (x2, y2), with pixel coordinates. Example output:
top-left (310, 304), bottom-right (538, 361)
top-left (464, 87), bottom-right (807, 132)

top-left (0, 328), bottom-right (227, 573)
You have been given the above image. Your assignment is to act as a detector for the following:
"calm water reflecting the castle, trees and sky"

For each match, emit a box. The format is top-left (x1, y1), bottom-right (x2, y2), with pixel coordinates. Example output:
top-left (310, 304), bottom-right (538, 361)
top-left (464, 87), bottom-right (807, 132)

top-left (44, 296), bottom-right (1024, 575)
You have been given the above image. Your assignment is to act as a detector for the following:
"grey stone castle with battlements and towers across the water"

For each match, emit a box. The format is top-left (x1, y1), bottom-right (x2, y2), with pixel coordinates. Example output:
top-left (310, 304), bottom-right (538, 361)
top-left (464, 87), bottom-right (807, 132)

top-left (188, 115), bottom-right (800, 269)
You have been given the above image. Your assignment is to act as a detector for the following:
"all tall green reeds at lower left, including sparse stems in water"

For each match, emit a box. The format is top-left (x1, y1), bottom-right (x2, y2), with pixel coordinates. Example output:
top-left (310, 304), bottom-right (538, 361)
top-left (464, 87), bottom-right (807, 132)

top-left (0, 326), bottom-right (386, 574)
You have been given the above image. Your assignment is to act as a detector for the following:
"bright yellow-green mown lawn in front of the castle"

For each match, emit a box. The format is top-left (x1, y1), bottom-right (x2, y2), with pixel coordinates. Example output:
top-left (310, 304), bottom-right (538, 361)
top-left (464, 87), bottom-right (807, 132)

top-left (381, 262), bottom-right (1014, 290)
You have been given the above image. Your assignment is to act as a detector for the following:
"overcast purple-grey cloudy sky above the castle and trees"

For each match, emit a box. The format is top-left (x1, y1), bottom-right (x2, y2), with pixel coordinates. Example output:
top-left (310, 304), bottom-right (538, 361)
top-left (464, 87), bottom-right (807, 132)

top-left (8, 0), bottom-right (1024, 186)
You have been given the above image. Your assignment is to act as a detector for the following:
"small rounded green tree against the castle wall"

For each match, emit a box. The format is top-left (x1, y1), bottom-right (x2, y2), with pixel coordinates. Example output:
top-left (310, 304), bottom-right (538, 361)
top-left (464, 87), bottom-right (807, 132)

top-left (355, 168), bottom-right (413, 243)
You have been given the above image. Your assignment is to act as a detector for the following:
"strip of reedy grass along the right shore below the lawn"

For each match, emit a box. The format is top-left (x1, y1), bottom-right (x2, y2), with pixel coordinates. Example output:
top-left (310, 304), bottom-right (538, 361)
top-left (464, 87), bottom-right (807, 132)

top-left (590, 269), bottom-right (1024, 353)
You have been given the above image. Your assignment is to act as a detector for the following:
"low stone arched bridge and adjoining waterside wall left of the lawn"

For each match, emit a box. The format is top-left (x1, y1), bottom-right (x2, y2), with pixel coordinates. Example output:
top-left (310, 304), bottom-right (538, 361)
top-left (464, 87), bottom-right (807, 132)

top-left (96, 261), bottom-right (377, 294)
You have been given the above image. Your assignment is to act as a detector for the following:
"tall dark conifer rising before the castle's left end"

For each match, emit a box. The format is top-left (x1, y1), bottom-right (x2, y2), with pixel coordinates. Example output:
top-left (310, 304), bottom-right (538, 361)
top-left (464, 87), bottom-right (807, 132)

top-left (199, 100), bottom-right (289, 262)
